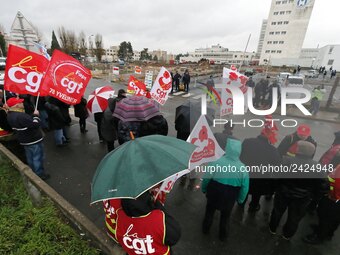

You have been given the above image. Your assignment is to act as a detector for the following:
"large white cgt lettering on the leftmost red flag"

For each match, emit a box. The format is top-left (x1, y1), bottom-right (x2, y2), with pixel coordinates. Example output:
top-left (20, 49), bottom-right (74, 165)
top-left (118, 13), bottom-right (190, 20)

top-left (8, 67), bottom-right (43, 93)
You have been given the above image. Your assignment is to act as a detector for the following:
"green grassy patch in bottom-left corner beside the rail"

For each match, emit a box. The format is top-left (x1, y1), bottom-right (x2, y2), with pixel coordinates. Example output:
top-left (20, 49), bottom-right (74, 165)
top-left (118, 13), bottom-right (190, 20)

top-left (0, 155), bottom-right (100, 255)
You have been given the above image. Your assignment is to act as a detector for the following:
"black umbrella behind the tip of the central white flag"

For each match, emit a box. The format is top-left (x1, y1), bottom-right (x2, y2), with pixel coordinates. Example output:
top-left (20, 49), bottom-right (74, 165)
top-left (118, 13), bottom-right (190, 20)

top-left (175, 101), bottom-right (215, 133)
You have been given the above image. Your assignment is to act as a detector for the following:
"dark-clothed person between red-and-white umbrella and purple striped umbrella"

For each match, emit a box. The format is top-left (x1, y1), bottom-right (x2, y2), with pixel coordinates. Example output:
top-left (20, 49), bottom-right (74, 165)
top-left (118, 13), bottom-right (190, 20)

top-left (101, 89), bottom-right (126, 152)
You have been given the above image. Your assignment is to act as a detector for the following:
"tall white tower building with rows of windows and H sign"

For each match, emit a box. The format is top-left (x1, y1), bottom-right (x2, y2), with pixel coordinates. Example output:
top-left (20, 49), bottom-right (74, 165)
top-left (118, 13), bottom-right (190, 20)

top-left (258, 0), bottom-right (314, 65)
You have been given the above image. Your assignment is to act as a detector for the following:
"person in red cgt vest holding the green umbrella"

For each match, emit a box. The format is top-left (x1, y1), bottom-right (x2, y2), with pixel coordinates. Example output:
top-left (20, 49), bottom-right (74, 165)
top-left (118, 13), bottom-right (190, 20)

top-left (104, 191), bottom-right (181, 255)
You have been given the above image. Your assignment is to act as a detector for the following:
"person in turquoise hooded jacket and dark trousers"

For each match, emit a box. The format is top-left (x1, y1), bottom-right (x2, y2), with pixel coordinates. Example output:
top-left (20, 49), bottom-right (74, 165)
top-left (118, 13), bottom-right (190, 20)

top-left (202, 138), bottom-right (249, 241)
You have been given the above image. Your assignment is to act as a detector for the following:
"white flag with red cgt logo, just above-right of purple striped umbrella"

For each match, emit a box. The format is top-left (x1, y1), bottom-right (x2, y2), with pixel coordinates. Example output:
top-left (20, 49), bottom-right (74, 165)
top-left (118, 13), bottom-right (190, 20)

top-left (150, 66), bottom-right (172, 105)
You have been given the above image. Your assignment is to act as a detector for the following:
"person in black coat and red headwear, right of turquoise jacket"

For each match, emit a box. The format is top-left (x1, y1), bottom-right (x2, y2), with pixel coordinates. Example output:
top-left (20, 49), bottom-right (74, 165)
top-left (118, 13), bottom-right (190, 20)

top-left (240, 123), bottom-right (281, 212)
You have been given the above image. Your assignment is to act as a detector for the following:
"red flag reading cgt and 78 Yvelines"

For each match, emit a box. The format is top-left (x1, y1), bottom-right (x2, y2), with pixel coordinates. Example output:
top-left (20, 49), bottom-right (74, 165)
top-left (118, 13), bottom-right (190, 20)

top-left (41, 50), bottom-right (92, 105)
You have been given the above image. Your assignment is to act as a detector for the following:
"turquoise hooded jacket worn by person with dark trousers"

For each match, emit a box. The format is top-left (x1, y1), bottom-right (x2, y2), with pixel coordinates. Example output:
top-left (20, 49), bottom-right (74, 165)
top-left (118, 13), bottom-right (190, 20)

top-left (202, 138), bottom-right (249, 203)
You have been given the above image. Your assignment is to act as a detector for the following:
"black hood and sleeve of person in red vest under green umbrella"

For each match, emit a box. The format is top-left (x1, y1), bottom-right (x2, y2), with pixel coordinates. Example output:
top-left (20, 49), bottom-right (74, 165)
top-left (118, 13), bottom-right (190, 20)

top-left (122, 192), bottom-right (181, 246)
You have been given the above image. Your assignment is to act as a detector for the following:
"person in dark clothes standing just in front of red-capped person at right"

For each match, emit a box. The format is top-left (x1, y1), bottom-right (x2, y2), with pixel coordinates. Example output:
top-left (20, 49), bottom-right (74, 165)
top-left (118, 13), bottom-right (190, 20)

top-left (269, 141), bottom-right (328, 240)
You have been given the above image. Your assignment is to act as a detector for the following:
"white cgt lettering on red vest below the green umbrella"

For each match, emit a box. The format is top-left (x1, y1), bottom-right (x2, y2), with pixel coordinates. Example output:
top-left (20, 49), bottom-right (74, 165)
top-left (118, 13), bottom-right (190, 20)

top-left (123, 224), bottom-right (156, 254)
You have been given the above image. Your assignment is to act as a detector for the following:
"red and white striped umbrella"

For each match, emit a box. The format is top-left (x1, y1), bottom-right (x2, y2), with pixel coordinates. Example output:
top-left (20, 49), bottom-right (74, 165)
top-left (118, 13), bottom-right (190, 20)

top-left (87, 86), bottom-right (115, 113)
